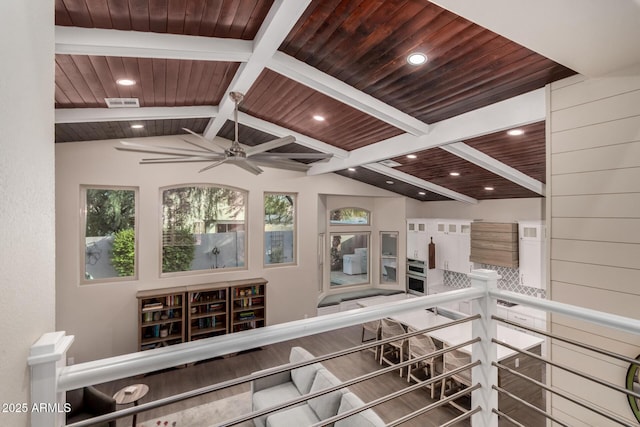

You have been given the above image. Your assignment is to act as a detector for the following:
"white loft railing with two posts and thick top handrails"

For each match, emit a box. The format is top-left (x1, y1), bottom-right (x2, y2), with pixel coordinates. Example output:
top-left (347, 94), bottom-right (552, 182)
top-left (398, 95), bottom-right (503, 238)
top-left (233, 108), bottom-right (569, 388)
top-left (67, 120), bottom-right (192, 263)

top-left (28, 270), bottom-right (640, 427)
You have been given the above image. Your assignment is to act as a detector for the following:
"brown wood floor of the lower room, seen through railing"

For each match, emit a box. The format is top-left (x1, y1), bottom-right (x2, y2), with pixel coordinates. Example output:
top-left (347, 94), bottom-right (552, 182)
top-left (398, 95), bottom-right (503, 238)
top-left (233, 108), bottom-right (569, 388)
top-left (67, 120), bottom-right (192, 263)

top-left (96, 327), bottom-right (544, 427)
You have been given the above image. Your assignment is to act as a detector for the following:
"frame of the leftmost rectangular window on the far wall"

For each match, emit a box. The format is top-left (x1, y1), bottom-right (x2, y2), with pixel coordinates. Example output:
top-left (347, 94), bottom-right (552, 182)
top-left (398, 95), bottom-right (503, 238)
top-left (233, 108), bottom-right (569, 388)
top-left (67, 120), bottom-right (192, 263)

top-left (79, 184), bottom-right (140, 286)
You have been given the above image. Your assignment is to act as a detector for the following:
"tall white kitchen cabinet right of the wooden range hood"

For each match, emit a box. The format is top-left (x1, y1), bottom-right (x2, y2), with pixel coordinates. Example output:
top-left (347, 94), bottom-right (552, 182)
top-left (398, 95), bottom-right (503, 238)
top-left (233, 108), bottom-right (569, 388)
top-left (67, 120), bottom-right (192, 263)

top-left (518, 221), bottom-right (545, 289)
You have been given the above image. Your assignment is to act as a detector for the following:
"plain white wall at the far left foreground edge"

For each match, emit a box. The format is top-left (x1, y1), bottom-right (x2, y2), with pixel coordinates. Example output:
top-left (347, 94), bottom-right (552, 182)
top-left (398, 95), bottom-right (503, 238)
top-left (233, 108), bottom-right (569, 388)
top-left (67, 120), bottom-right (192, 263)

top-left (0, 0), bottom-right (55, 426)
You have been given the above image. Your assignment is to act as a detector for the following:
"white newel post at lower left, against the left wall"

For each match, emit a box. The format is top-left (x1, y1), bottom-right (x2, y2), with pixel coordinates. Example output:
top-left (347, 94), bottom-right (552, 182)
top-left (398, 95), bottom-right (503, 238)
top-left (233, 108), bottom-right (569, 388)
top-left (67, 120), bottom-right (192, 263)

top-left (27, 331), bottom-right (74, 427)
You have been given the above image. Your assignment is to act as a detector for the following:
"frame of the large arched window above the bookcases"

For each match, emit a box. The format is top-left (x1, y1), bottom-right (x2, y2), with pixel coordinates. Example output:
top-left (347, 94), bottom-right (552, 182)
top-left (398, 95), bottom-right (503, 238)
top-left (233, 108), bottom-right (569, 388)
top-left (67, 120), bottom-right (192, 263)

top-left (158, 182), bottom-right (250, 278)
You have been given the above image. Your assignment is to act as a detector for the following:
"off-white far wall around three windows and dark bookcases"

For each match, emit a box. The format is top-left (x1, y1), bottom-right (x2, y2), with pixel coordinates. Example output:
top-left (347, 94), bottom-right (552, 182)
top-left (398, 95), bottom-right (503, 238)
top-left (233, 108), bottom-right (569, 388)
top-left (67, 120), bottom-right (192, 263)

top-left (56, 137), bottom-right (404, 362)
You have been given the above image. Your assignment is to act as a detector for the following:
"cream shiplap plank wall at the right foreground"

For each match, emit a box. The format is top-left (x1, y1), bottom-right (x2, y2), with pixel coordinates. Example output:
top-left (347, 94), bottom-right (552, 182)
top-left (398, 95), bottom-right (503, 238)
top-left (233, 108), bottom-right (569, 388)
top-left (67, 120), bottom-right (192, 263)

top-left (547, 72), bottom-right (640, 426)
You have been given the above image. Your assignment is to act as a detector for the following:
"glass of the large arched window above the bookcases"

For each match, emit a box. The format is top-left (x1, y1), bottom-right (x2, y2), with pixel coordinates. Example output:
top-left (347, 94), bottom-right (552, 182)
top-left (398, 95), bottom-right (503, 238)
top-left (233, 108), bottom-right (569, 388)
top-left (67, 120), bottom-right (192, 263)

top-left (162, 184), bottom-right (247, 273)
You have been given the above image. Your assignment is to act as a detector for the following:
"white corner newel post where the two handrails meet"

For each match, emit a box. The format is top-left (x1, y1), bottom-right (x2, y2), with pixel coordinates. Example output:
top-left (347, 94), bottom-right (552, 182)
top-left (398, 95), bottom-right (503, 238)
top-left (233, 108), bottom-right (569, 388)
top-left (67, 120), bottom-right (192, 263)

top-left (469, 269), bottom-right (499, 427)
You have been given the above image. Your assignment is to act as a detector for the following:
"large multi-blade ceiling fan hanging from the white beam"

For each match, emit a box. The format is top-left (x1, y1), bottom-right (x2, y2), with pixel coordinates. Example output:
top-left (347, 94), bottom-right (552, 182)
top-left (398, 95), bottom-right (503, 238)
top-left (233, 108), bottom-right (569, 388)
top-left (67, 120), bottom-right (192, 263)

top-left (116, 92), bottom-right (332, 175)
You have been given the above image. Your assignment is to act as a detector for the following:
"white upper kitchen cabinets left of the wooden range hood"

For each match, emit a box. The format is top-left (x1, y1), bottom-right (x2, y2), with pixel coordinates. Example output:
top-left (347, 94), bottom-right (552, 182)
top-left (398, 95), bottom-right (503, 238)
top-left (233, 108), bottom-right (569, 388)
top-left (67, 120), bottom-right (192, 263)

top-left (434, 220), bottom-right (473, 273)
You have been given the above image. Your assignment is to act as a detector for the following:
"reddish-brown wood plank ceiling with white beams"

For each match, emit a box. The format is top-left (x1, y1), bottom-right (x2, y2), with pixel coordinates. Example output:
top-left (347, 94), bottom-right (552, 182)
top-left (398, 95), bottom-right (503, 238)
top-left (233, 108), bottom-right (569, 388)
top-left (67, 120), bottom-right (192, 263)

top-left (55, 0), bottom-right (575, 201)
